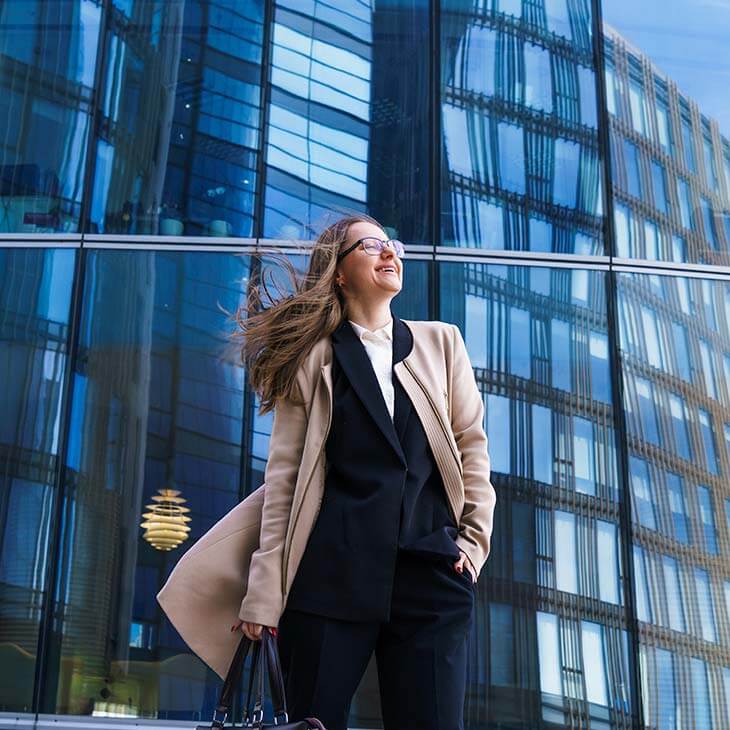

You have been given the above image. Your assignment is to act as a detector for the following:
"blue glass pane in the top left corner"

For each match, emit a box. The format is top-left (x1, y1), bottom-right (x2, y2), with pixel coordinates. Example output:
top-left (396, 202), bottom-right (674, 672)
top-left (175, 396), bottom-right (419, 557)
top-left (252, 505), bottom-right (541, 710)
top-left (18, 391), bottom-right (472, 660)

top-left (0, 0), bottom-right (101, 233)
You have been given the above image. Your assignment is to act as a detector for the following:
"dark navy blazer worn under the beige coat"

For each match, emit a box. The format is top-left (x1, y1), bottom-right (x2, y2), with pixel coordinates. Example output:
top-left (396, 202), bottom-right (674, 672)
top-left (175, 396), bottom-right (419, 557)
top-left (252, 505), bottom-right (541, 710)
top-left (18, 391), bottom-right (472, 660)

top-left (287, 315), bottom-right (459, 621)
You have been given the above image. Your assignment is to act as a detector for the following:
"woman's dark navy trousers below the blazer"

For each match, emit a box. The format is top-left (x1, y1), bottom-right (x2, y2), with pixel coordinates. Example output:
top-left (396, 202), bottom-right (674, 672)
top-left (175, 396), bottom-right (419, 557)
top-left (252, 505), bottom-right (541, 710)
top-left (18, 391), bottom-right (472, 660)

top-left (278, 551), bottom-right (476, 730)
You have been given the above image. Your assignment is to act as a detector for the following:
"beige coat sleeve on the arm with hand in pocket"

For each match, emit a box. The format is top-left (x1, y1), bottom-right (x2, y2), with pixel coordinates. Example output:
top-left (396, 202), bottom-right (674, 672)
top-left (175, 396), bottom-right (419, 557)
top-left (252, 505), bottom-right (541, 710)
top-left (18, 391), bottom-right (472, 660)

top-left (449, 325), bottom-right (497, 575)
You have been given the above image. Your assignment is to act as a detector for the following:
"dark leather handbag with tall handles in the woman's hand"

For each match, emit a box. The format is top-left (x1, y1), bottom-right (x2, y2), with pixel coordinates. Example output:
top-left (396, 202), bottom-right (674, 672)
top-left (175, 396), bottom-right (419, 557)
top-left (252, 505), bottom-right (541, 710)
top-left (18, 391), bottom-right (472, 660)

top-left (195, 627), bottom-right (326, 730)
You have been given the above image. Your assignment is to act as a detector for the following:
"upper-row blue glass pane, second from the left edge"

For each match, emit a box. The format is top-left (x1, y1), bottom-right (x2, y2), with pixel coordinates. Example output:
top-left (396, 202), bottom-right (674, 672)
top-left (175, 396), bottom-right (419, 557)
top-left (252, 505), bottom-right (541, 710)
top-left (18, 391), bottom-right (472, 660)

top-left (88, 0), bottom-right (263, 236)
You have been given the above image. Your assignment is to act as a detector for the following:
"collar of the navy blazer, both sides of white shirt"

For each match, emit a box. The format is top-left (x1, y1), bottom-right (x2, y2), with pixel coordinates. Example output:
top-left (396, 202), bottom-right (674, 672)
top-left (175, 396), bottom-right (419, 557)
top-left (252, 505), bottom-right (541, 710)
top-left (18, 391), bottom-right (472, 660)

top-left (332, 315), bottom-right (413, 465)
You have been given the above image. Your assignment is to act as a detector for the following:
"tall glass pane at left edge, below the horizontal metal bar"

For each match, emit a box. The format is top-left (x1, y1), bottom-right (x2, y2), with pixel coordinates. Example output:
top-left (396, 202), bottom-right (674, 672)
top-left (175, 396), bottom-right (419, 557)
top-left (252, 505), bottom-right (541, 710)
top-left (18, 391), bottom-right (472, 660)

top-left (0, 248), bottom-right (75, 712)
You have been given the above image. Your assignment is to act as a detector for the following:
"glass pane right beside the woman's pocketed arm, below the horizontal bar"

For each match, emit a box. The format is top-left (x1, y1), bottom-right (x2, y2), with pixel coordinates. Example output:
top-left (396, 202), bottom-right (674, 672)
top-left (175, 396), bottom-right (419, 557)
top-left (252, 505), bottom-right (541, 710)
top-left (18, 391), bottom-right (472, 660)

top-left (438, 262), bottom-right (631, 727)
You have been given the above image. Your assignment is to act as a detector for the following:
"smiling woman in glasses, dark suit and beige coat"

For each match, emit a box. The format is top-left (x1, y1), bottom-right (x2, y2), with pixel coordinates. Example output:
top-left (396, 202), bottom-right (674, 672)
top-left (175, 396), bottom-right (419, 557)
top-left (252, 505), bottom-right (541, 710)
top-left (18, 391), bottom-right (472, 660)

top-left (232, 215), bottom-right (495, 730)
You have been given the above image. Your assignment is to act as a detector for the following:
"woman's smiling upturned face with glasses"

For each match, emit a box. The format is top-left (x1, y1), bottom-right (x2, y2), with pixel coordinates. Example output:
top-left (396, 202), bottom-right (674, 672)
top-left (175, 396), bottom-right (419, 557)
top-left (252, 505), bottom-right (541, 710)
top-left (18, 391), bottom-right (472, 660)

top-left (335, 221), bottom-right (403, 299)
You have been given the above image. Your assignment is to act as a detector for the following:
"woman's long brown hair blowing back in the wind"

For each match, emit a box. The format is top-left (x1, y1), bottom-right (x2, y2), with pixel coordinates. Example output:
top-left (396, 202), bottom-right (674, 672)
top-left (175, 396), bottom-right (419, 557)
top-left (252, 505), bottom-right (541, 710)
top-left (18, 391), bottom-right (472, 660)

top-left (231, 213), bottom-right (382, 415)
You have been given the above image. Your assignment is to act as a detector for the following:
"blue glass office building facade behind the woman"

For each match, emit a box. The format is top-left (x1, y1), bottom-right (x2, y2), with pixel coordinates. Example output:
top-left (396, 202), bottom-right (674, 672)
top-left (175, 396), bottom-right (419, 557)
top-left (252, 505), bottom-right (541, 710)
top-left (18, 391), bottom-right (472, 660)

top-left (0, 0), bottom-right (730, 730)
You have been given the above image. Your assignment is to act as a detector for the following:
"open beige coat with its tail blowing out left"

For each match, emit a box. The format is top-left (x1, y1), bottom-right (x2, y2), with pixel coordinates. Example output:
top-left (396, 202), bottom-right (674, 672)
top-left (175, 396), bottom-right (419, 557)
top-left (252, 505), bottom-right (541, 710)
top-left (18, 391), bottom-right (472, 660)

top-left (157, 320), bottom-right (496, 677)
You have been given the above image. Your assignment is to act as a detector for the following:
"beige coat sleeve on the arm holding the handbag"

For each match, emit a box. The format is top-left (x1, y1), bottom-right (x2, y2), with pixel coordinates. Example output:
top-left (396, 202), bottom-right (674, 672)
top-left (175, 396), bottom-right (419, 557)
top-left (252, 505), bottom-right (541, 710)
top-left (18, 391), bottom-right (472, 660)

top-left (238, 368), bottom-right (310, 626)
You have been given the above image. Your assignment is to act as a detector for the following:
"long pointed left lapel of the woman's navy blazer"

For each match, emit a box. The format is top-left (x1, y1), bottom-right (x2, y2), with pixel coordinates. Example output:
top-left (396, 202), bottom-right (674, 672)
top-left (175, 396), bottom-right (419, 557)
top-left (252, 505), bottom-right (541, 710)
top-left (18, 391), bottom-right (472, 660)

top-left (332, 319), bottom-right (406, 465)
